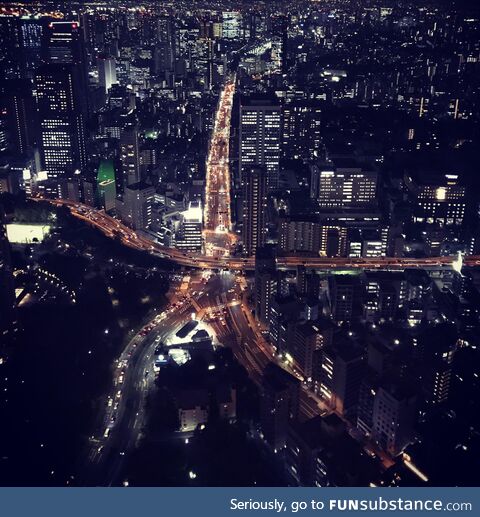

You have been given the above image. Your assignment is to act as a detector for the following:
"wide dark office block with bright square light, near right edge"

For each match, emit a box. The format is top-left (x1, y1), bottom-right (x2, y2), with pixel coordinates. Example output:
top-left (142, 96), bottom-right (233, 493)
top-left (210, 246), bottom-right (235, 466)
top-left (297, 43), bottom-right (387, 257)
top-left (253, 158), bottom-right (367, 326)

top-left (404, 171), bottom-right (466, 226)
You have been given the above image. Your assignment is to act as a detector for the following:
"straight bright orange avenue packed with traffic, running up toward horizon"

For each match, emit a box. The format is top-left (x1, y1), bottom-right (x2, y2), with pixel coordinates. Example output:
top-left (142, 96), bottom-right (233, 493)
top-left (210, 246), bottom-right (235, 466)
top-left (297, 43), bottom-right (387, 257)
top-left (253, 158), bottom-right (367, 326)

top-left (204, 76), bottom-right (235, 256)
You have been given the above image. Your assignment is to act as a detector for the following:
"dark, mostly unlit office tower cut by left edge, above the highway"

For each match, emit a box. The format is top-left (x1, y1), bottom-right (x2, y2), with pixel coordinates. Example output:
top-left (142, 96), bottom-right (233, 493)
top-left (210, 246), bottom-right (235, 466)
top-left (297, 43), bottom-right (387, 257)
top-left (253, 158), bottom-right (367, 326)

top-left (0, 80), bottom-right (33, 155)
